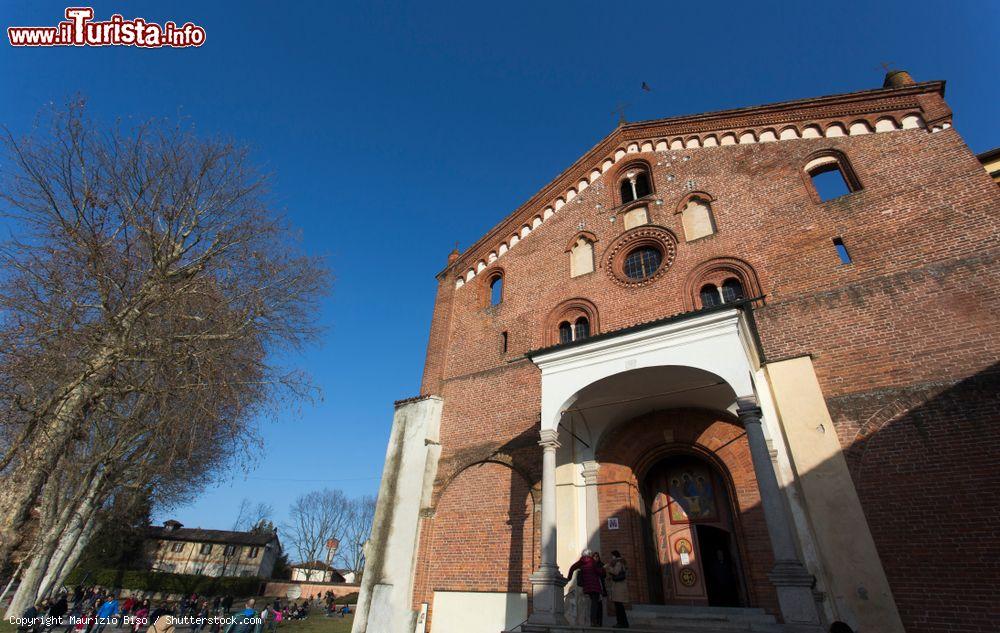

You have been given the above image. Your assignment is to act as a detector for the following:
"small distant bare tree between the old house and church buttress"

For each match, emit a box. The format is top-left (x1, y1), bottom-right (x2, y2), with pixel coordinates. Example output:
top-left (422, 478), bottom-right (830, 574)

top-left (282, 489), bottom-right (351, 562)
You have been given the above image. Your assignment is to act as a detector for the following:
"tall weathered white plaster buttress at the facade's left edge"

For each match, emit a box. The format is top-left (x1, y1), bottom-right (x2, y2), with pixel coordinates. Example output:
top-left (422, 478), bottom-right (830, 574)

top-left (351, 396), bottom-right (442, 633)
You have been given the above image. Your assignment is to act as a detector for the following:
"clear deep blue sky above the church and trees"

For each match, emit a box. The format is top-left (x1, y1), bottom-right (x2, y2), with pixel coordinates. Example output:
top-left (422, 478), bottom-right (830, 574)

top-left (0, 0), bottom-right (1000, 528)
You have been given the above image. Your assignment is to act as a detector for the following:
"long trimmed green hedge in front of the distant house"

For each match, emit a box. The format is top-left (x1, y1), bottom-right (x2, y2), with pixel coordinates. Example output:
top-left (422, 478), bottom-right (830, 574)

top-left (66, 569), bottom-right (263, 596)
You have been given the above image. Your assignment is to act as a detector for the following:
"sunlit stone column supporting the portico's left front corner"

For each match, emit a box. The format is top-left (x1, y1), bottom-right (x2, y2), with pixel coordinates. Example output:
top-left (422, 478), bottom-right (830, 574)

top-left (528, 429), bottom-right (566, 624)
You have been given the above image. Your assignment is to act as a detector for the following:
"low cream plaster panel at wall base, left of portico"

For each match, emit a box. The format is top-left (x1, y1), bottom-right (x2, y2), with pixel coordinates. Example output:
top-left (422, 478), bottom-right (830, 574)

top-left (431, 591), bottom-right (528, 633)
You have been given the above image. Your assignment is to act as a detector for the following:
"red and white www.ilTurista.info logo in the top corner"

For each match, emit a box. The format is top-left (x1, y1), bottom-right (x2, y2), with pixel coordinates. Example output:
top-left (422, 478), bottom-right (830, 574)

top-left (7, 7), bottom-right (205, 48)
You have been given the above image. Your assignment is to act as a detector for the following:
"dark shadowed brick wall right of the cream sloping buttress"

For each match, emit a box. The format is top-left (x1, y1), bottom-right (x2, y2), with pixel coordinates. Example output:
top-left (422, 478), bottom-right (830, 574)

top-left (828, 364), bottom-right (1000, 633)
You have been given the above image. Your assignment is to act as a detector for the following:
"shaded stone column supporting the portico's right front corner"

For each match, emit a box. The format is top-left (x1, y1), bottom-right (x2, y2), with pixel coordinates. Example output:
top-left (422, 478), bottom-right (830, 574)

top-left (737, 398), bottom-right (821, 626)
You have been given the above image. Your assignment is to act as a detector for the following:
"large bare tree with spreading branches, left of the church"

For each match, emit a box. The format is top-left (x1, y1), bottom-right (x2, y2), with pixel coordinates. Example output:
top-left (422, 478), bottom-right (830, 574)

top-left (0, 104), bottom-right (327, 568)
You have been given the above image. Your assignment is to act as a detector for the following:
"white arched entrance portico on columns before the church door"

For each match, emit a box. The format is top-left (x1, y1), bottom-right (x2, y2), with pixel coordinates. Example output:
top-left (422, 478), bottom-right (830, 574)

top-left (529, 310), bottom-right (820, 625)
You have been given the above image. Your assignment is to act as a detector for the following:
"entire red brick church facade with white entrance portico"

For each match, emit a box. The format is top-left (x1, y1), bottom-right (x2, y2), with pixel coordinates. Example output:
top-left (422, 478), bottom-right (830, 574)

top-left (354, 72), bottom-right (1000, 633)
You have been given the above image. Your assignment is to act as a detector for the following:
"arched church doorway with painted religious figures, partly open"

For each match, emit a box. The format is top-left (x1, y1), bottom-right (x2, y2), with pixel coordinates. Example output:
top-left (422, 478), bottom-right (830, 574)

top-left (645, 455), bottom-right (742, 606)
